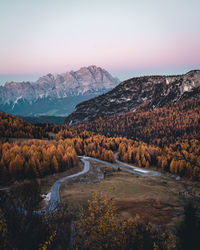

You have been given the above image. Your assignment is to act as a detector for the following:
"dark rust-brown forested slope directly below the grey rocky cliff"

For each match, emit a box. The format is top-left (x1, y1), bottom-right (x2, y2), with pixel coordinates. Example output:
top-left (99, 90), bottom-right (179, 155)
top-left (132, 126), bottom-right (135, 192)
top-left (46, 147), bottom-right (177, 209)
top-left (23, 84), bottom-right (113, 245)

top-left (77, 99), bottom-right (200, 146)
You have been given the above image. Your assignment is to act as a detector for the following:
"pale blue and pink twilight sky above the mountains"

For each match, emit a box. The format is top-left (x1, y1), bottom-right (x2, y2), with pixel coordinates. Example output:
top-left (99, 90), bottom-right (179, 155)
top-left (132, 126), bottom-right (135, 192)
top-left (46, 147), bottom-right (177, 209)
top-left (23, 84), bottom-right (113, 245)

top-left (0, 0), bottom-right (200, 84)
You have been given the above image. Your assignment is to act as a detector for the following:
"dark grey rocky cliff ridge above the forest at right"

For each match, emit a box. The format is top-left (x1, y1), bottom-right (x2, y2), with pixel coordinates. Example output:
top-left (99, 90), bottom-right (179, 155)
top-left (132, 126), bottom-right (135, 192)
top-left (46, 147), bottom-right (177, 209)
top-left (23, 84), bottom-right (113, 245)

top-left (66, 70), bottom-right (200, 125)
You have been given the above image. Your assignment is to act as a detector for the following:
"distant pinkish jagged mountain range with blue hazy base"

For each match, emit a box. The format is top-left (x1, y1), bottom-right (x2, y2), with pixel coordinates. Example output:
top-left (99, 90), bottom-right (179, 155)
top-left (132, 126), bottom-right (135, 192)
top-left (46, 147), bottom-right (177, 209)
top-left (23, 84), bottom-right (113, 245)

top-left (0, 66), bottom-right (119, 116)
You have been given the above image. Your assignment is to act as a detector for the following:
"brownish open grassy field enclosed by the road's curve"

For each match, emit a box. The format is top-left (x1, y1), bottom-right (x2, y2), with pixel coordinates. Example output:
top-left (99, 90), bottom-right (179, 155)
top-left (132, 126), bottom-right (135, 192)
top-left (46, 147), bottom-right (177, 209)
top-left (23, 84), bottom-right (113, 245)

top-left (60, 161), bottom-right (200, 225)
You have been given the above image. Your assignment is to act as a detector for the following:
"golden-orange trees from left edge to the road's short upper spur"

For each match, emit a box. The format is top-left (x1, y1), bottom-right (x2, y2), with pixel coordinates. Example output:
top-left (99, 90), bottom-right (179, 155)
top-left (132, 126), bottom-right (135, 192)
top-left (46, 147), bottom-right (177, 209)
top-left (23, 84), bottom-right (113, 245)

top-left (0, 130), bottom-right (120, 184)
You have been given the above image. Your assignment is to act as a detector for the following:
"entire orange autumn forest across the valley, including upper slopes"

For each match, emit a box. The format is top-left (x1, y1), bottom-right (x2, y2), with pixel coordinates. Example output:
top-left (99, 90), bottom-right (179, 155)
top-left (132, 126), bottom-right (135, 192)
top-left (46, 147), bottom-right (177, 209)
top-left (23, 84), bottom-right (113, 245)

top-left (0, 100), bottom-right (200, 186)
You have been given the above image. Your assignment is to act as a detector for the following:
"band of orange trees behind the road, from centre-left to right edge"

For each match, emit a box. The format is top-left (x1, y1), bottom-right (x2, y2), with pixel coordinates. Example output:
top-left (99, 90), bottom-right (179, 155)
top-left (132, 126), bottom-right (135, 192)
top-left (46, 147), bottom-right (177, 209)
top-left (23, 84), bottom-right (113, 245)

top-left (57, 129), bottom-right (200, 180)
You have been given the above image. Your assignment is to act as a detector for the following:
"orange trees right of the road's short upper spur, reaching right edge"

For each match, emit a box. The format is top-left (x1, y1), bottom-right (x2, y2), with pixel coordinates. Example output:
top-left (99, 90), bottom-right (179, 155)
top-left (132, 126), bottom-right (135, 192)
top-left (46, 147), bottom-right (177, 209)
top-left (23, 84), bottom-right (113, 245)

top-left (118, 139), bottom-right (200, 180)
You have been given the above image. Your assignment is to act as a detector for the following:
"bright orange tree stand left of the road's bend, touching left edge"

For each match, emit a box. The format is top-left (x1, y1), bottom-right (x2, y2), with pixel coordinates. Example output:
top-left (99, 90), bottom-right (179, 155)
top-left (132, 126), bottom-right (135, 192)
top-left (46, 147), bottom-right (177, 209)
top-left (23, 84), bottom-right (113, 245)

top-left (0, 140), bottom-right (78, 183)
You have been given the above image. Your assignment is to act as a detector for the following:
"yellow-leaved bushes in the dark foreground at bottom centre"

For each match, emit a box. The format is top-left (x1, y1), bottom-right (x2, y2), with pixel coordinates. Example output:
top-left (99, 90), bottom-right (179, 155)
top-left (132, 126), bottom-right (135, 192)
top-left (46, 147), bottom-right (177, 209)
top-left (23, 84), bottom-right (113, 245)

top-left (74, 194), bottom-right (176, 250)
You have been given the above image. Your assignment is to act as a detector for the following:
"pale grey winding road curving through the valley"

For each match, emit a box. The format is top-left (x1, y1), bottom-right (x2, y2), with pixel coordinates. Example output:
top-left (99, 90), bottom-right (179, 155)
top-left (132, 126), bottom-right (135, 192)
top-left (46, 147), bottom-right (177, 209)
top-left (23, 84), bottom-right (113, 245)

top-left (39, 153), bottom-right (160, 213)
